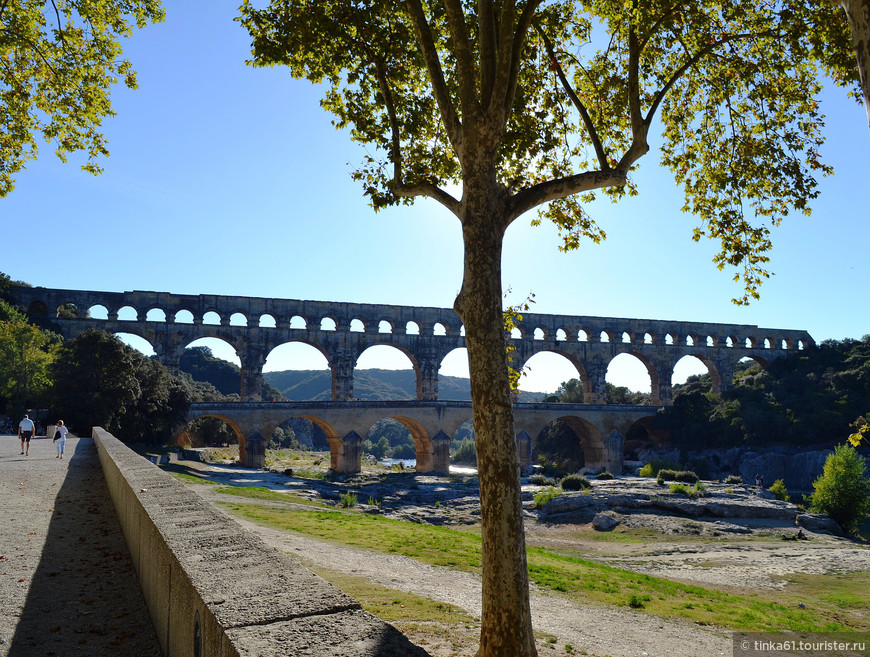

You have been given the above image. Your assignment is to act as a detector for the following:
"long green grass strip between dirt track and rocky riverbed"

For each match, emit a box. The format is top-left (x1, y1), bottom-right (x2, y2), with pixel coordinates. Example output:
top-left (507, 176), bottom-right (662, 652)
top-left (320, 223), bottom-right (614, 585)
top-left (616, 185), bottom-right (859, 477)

top-left (223, 503), bottom-right (868, 632)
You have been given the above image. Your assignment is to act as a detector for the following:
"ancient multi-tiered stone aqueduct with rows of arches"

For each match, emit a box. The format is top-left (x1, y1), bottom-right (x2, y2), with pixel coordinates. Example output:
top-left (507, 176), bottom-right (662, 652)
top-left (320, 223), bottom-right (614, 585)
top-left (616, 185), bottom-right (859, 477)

top-left (11, 286), bottom-right (814, 471)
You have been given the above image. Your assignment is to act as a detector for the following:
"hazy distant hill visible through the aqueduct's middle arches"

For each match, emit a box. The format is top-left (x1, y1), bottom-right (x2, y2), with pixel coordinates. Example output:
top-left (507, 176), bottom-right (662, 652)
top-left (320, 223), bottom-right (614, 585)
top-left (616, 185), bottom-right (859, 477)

top-left (263, 370), bottom-right (546, 402)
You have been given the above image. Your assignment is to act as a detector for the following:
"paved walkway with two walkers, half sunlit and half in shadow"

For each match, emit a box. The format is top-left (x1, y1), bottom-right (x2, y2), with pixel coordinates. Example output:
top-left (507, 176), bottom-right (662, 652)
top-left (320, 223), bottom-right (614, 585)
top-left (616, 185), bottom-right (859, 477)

top-left (0, 436), bottom-right (161, 657)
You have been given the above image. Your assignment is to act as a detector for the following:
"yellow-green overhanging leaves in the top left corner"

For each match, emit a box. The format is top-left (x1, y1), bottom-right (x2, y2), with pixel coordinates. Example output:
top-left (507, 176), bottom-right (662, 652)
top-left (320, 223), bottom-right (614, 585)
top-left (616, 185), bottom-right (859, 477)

top-left (0, 0), bottom-right (163, 198)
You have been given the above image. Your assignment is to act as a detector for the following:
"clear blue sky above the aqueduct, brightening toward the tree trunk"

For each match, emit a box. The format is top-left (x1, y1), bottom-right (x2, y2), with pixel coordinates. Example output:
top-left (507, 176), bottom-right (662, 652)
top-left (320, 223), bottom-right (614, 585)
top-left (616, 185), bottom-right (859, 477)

top-left (0, 0), bottom-right (870, 390)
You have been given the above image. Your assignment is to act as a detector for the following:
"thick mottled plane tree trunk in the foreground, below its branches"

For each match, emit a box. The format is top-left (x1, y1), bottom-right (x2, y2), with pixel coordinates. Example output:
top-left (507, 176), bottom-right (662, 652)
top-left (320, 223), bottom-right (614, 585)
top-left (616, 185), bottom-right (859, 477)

top-left (455, 177), bottom-right (537, 657)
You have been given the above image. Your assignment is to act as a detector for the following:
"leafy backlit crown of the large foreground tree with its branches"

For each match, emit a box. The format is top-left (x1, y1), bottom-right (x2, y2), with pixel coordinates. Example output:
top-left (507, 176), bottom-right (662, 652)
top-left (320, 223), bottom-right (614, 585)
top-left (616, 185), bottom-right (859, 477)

top-left (240, 0), bottom-right (856, 303)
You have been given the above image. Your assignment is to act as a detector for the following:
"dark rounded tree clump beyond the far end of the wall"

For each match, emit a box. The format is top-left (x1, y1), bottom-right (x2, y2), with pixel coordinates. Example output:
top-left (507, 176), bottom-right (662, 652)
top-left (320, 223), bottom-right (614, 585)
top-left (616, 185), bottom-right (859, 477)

top-left (52, 329), bottom-right (190, 443)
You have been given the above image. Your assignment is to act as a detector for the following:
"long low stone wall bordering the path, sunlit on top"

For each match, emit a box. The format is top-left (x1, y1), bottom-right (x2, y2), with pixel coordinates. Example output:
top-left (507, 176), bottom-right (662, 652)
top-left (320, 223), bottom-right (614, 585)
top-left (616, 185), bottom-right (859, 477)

top-left (93, 427), bottom-right (427, 657)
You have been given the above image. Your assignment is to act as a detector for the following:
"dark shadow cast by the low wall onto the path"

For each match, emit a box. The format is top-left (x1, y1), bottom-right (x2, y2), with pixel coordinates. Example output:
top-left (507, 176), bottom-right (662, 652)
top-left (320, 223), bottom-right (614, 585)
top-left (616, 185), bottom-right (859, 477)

top-left (9, 438), bottom-right (161, 657)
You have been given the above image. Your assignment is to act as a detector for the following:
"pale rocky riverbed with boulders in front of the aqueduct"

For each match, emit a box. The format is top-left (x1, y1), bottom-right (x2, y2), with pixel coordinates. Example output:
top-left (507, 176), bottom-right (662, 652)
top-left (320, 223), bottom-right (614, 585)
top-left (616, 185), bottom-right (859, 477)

top-left (172, 462), bottom-right (870, 588)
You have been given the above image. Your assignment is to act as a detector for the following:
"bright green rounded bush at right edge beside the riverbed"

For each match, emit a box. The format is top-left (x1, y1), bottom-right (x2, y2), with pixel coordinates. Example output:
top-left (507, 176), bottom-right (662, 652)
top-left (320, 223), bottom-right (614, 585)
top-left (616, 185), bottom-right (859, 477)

top-left (810, 445), bottom-right (870, 531)
